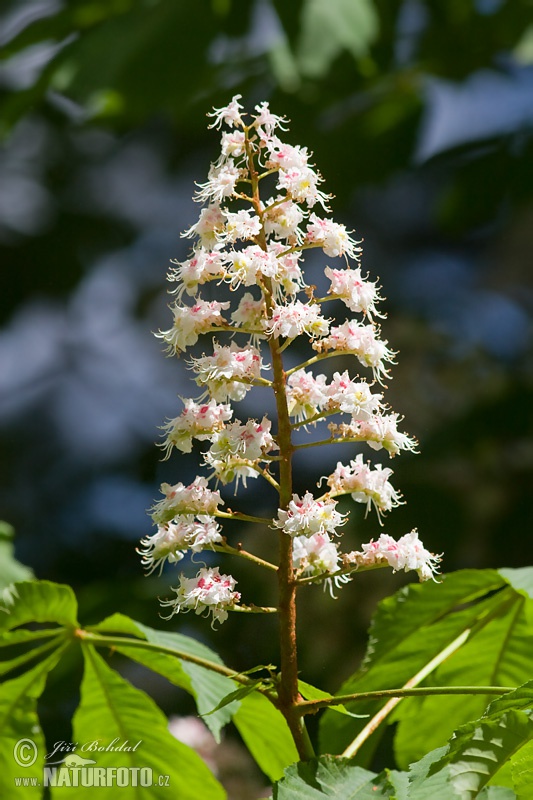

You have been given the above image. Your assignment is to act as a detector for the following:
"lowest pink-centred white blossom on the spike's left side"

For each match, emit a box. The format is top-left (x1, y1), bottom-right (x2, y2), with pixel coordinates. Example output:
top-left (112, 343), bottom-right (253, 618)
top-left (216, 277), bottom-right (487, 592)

top-left (161, 567), bottom-right (241, 622)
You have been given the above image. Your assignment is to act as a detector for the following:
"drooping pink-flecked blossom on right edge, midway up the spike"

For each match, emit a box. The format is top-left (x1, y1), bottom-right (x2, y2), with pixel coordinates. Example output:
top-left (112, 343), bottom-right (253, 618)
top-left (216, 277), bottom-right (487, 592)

top-left (313, 320), bottom-right (395, 383)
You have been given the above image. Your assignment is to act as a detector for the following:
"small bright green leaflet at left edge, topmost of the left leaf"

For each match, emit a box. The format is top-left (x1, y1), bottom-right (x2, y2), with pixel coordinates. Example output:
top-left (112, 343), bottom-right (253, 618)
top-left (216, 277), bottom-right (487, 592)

top-left (0, 581), bottom-right (78, 631)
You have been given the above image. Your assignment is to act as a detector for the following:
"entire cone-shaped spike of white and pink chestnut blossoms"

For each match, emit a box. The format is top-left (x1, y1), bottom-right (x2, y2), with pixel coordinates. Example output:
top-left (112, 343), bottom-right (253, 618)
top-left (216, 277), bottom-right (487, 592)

top-left (143, 96), bottom-right (439, 622)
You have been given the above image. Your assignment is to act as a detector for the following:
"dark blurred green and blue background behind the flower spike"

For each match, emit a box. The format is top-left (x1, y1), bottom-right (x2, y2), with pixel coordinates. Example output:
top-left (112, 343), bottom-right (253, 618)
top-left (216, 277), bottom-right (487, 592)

top-left (0, 0), bottom-right (533, 788)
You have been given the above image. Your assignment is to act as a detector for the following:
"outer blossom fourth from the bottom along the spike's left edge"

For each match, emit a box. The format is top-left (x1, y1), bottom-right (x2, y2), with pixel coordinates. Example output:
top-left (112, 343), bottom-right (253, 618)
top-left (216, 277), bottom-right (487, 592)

top-left (161, 399), bottom-right (233, 458)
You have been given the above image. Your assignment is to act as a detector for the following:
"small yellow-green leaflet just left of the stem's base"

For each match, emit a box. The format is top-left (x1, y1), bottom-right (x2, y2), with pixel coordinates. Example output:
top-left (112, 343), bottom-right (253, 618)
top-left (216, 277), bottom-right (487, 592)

top-left (233, 692), bottom-right (298, 781)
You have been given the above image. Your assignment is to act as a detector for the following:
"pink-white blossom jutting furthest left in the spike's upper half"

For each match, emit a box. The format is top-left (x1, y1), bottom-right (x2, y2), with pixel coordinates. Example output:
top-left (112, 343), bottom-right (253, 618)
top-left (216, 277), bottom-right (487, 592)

top-left (155, 298), bottom-right (230, 354)
